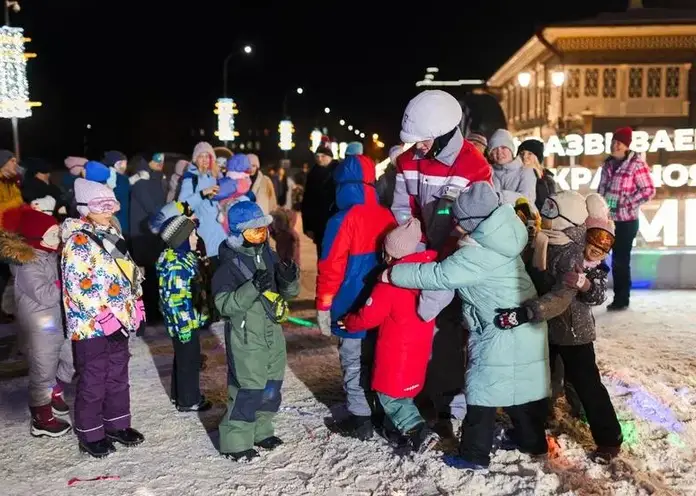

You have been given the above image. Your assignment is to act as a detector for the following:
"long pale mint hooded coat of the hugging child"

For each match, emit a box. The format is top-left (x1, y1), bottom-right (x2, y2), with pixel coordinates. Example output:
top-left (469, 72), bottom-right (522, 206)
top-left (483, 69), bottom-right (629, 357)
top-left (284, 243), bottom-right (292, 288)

top-left (390, 205), bottom-right (550, 407)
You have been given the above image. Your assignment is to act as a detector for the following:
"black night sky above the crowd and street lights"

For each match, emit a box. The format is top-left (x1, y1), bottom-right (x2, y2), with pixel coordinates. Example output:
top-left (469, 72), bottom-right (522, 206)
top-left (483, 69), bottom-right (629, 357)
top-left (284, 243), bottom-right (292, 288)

top-left (0, 0), bottom-right (627, 164)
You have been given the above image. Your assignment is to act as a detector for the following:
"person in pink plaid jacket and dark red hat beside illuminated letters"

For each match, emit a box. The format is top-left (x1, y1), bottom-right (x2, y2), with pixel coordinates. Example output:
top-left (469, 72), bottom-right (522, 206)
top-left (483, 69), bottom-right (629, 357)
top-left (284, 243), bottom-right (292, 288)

top-left (597, 127), bottom-right (655, 311)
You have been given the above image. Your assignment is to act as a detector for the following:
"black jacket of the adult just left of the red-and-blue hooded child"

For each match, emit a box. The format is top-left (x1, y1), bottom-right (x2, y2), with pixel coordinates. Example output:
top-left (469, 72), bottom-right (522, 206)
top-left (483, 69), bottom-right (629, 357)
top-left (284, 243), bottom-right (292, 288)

top-left (302, 160), bottom-right (338, 243)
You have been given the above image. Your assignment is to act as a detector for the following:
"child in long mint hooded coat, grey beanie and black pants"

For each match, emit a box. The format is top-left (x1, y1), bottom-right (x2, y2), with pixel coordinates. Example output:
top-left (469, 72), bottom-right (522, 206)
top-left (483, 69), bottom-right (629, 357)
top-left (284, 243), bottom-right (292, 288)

top-left (383, 182), bottom-right (550, 469)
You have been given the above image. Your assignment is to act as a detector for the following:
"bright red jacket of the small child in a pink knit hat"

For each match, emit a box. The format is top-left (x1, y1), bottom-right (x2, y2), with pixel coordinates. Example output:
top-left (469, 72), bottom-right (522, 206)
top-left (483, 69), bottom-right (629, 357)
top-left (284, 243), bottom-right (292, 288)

top-left (344, 250), bottom-right (437, 398)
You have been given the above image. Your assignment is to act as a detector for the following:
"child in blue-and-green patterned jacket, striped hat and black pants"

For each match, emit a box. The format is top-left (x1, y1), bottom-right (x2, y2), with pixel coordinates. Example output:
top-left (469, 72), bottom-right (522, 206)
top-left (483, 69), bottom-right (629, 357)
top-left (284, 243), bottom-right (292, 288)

top-left (157, 204), bottom-right (212, 412)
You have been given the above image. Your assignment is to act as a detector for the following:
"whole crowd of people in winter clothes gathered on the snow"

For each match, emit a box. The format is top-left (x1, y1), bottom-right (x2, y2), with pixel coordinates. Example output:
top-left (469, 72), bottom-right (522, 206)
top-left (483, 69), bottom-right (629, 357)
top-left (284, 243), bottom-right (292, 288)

top-left (0, 90), bottom-right (655, 470)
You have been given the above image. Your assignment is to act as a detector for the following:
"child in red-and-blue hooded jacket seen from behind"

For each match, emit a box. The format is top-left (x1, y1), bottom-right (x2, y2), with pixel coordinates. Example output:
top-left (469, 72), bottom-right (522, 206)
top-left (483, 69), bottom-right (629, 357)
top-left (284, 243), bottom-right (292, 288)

top-left (316, 155), bottom-right (396, 440)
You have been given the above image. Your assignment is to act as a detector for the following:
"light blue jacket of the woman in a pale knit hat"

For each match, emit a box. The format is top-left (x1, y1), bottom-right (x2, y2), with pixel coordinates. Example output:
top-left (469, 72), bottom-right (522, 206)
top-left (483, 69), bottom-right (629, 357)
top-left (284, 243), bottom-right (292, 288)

top-left (179, 164), bottom-right (227, 257)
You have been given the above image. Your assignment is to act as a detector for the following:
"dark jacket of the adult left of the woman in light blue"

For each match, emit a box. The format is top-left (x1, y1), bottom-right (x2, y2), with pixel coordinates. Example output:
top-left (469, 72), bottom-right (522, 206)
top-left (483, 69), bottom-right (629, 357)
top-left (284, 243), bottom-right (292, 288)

top-left (129, 158), bottom-right (166, 266)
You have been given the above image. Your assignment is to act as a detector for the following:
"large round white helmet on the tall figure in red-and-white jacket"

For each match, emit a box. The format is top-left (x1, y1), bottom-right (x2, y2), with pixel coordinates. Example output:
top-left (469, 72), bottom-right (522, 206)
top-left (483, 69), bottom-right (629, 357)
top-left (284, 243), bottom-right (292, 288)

top-left (400, 90), bottom-right (462, 143)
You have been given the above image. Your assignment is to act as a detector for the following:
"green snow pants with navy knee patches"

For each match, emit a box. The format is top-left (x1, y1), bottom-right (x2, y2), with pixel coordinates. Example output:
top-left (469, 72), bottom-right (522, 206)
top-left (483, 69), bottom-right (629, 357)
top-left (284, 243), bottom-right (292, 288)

top-left (219, 322), bottom-right (287, 453)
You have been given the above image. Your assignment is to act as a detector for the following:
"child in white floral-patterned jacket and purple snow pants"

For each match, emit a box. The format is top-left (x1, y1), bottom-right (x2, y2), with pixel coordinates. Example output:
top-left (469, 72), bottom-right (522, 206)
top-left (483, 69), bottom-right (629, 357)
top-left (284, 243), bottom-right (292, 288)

top-left (61, 178), bottom-right (145, 458)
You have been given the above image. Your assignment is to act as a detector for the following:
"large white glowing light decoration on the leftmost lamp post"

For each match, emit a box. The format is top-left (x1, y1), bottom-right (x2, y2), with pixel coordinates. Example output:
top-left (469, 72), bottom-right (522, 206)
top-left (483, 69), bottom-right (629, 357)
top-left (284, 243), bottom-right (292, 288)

top-left (0, 26), bottom-right (33, 118)
